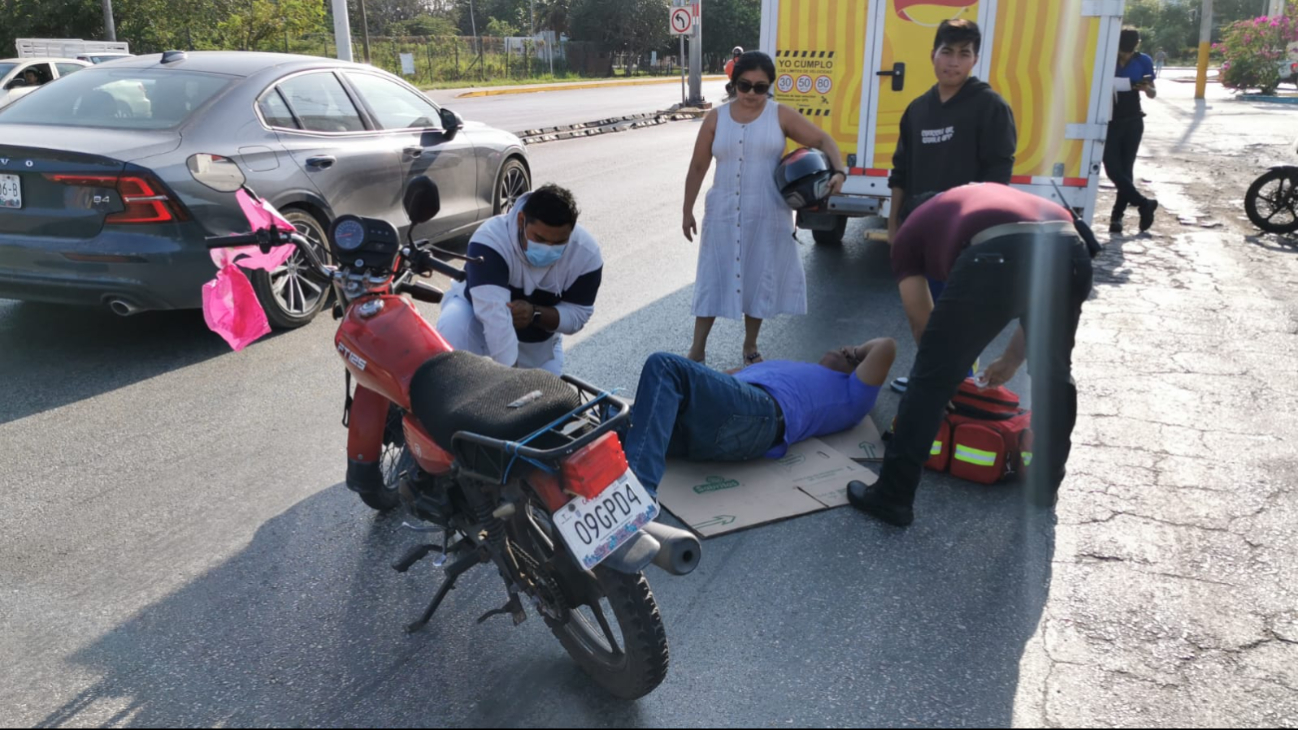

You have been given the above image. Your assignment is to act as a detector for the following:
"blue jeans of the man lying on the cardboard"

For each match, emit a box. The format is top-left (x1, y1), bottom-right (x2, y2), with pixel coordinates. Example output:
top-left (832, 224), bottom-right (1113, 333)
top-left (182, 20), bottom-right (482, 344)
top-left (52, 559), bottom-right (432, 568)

top-left (622, 352), bottom-right (779, 492)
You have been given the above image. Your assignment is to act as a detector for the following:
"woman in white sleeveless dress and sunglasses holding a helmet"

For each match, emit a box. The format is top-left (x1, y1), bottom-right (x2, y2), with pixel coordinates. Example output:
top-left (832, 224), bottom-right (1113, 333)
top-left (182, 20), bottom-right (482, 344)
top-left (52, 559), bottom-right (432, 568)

top-left (683, 51), bottom-right (848, 365)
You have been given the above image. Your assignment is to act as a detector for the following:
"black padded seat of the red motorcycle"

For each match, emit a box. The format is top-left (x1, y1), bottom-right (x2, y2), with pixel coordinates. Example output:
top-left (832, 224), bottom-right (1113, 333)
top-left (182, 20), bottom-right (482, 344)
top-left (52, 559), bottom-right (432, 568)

top-left (410, 351), bottom-right (582, 451)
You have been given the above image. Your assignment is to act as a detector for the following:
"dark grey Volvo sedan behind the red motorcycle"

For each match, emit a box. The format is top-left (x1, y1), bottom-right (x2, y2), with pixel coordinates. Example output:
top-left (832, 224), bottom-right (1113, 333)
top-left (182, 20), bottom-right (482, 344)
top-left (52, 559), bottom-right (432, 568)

top-left (0, 52), bottom-right (531, 327)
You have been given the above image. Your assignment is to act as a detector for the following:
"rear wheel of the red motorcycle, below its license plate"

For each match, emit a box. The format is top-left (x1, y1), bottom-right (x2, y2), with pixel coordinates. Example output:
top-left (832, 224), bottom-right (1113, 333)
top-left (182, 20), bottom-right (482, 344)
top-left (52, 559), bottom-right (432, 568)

top-left (511, 496), bottom-right (670, 700)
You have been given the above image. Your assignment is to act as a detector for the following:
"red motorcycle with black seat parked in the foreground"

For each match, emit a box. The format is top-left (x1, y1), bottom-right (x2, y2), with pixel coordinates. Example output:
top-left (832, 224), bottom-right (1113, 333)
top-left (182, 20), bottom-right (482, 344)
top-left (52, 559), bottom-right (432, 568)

top-left (191, 156), bottom-right (700, 699)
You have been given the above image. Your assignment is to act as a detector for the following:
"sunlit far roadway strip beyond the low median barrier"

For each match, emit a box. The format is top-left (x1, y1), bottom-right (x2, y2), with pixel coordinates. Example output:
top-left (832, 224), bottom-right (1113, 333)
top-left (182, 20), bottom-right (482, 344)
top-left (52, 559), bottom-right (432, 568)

top-left (428, 82), bottom-right (726, 131)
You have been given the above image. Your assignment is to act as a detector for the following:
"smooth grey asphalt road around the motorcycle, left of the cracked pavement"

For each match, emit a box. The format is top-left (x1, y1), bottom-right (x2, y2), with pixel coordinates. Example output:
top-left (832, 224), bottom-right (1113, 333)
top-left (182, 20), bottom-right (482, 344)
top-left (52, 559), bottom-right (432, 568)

top-left (0, 96), bottom-right (1051, 726)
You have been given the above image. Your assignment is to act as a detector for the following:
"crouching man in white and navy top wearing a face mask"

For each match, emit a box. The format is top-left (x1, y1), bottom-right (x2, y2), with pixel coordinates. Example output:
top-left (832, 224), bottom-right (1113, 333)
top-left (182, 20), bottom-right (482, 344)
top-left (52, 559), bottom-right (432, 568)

top-left (437, 184), bottom-right (604, 375)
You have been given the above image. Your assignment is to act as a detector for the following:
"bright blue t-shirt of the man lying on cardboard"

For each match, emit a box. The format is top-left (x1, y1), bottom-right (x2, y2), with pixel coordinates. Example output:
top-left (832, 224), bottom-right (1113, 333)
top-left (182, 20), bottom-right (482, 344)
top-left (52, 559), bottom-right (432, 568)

top-left (735, 360), bottom-right (879, 459)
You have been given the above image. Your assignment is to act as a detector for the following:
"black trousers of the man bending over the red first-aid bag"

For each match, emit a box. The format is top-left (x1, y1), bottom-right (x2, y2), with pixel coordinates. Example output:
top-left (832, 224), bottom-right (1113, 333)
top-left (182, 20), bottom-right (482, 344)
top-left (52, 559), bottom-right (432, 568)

top-left (879, 234), bottom-right (1092, 503)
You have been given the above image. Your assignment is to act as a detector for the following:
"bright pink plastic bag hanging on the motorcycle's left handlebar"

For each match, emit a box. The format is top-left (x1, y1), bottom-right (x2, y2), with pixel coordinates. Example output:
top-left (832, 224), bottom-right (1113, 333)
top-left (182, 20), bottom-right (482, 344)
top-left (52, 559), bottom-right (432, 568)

top-left (202, 190), bottom-right (296, 352)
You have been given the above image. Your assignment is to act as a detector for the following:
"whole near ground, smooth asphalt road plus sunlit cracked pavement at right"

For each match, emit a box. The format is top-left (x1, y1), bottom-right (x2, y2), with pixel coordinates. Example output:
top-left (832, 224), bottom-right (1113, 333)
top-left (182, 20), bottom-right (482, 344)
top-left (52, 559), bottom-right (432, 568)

top-left (0, 72), bottom-right (1298, 727)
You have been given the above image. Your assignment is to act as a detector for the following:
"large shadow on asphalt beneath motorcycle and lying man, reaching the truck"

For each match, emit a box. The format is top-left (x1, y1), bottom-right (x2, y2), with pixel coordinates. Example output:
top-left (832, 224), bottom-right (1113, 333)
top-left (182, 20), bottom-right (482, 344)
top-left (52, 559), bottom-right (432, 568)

top-left (30, 233), bottom-right (1054, 727)
